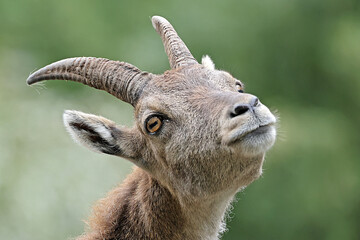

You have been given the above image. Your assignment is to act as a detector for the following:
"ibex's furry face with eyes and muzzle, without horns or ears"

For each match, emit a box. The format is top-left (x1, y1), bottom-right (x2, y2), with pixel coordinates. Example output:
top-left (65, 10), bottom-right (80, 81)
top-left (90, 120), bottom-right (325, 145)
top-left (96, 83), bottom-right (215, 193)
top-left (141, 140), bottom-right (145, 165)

top-left (135, 65), bottom-right (276, 197)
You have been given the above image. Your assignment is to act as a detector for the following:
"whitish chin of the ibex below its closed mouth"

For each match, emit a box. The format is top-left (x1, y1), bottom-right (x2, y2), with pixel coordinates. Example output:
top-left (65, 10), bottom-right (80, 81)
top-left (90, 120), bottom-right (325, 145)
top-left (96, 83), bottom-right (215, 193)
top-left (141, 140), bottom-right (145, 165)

top-left (237, 125), bottom-right (276, 157)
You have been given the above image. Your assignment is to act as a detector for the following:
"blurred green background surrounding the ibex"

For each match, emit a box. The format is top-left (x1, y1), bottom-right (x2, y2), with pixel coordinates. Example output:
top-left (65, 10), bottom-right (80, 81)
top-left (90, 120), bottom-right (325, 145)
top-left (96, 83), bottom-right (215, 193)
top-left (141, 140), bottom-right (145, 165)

top-left (0, 0), bottom-right (360, 240)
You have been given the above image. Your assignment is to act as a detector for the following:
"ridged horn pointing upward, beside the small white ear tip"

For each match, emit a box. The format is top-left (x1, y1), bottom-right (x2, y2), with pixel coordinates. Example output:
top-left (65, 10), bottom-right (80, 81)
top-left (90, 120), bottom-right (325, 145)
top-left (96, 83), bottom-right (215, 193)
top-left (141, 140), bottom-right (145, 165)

top-left (151, 16), bottom-right (198, 68)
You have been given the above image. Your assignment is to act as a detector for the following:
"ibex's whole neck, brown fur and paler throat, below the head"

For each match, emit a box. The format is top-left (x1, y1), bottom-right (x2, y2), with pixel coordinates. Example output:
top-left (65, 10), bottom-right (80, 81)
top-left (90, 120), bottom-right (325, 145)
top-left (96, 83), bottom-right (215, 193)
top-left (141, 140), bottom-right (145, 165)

top-left (78, 168), bottom-right (233, 240)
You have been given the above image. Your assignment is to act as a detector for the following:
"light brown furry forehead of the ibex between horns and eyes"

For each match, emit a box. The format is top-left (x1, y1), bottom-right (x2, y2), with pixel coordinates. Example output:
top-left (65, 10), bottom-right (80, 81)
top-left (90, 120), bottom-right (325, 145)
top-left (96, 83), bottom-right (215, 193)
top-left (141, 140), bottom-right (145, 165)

top-left (135, 65), bottom-right (240, 114)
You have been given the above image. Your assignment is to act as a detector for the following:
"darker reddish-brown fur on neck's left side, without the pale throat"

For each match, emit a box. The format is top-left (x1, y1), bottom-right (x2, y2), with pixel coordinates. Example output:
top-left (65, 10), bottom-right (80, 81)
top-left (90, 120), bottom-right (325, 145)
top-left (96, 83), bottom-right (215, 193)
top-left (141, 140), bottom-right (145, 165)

top-left (78, 168), bottom-right (184, 240)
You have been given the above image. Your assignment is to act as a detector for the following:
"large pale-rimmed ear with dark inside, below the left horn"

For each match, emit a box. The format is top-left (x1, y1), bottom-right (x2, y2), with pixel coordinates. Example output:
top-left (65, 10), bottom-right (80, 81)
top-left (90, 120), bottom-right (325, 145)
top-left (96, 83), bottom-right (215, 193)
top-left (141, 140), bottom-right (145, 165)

top-left (63, 110), bottom-right (142, 161)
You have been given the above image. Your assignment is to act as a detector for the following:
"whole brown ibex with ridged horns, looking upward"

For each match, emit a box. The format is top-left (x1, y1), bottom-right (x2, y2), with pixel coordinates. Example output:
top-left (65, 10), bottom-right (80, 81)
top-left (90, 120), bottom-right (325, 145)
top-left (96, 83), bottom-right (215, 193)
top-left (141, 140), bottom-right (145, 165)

top-left (27, 16), bottom-right (276, 240)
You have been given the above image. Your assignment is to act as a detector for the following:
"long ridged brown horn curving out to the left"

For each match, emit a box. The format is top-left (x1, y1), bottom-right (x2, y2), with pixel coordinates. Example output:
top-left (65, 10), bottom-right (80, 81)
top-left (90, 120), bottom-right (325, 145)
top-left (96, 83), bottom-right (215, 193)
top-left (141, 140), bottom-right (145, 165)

top-left (26, 57), bottom-right (152, 106)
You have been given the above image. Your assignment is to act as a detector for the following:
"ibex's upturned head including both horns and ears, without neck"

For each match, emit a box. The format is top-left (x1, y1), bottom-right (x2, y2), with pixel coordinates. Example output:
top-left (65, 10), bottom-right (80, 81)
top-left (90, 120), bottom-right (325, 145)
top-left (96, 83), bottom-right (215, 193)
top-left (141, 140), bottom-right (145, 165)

top-left (27, 16), bottom-right (276, 199)
